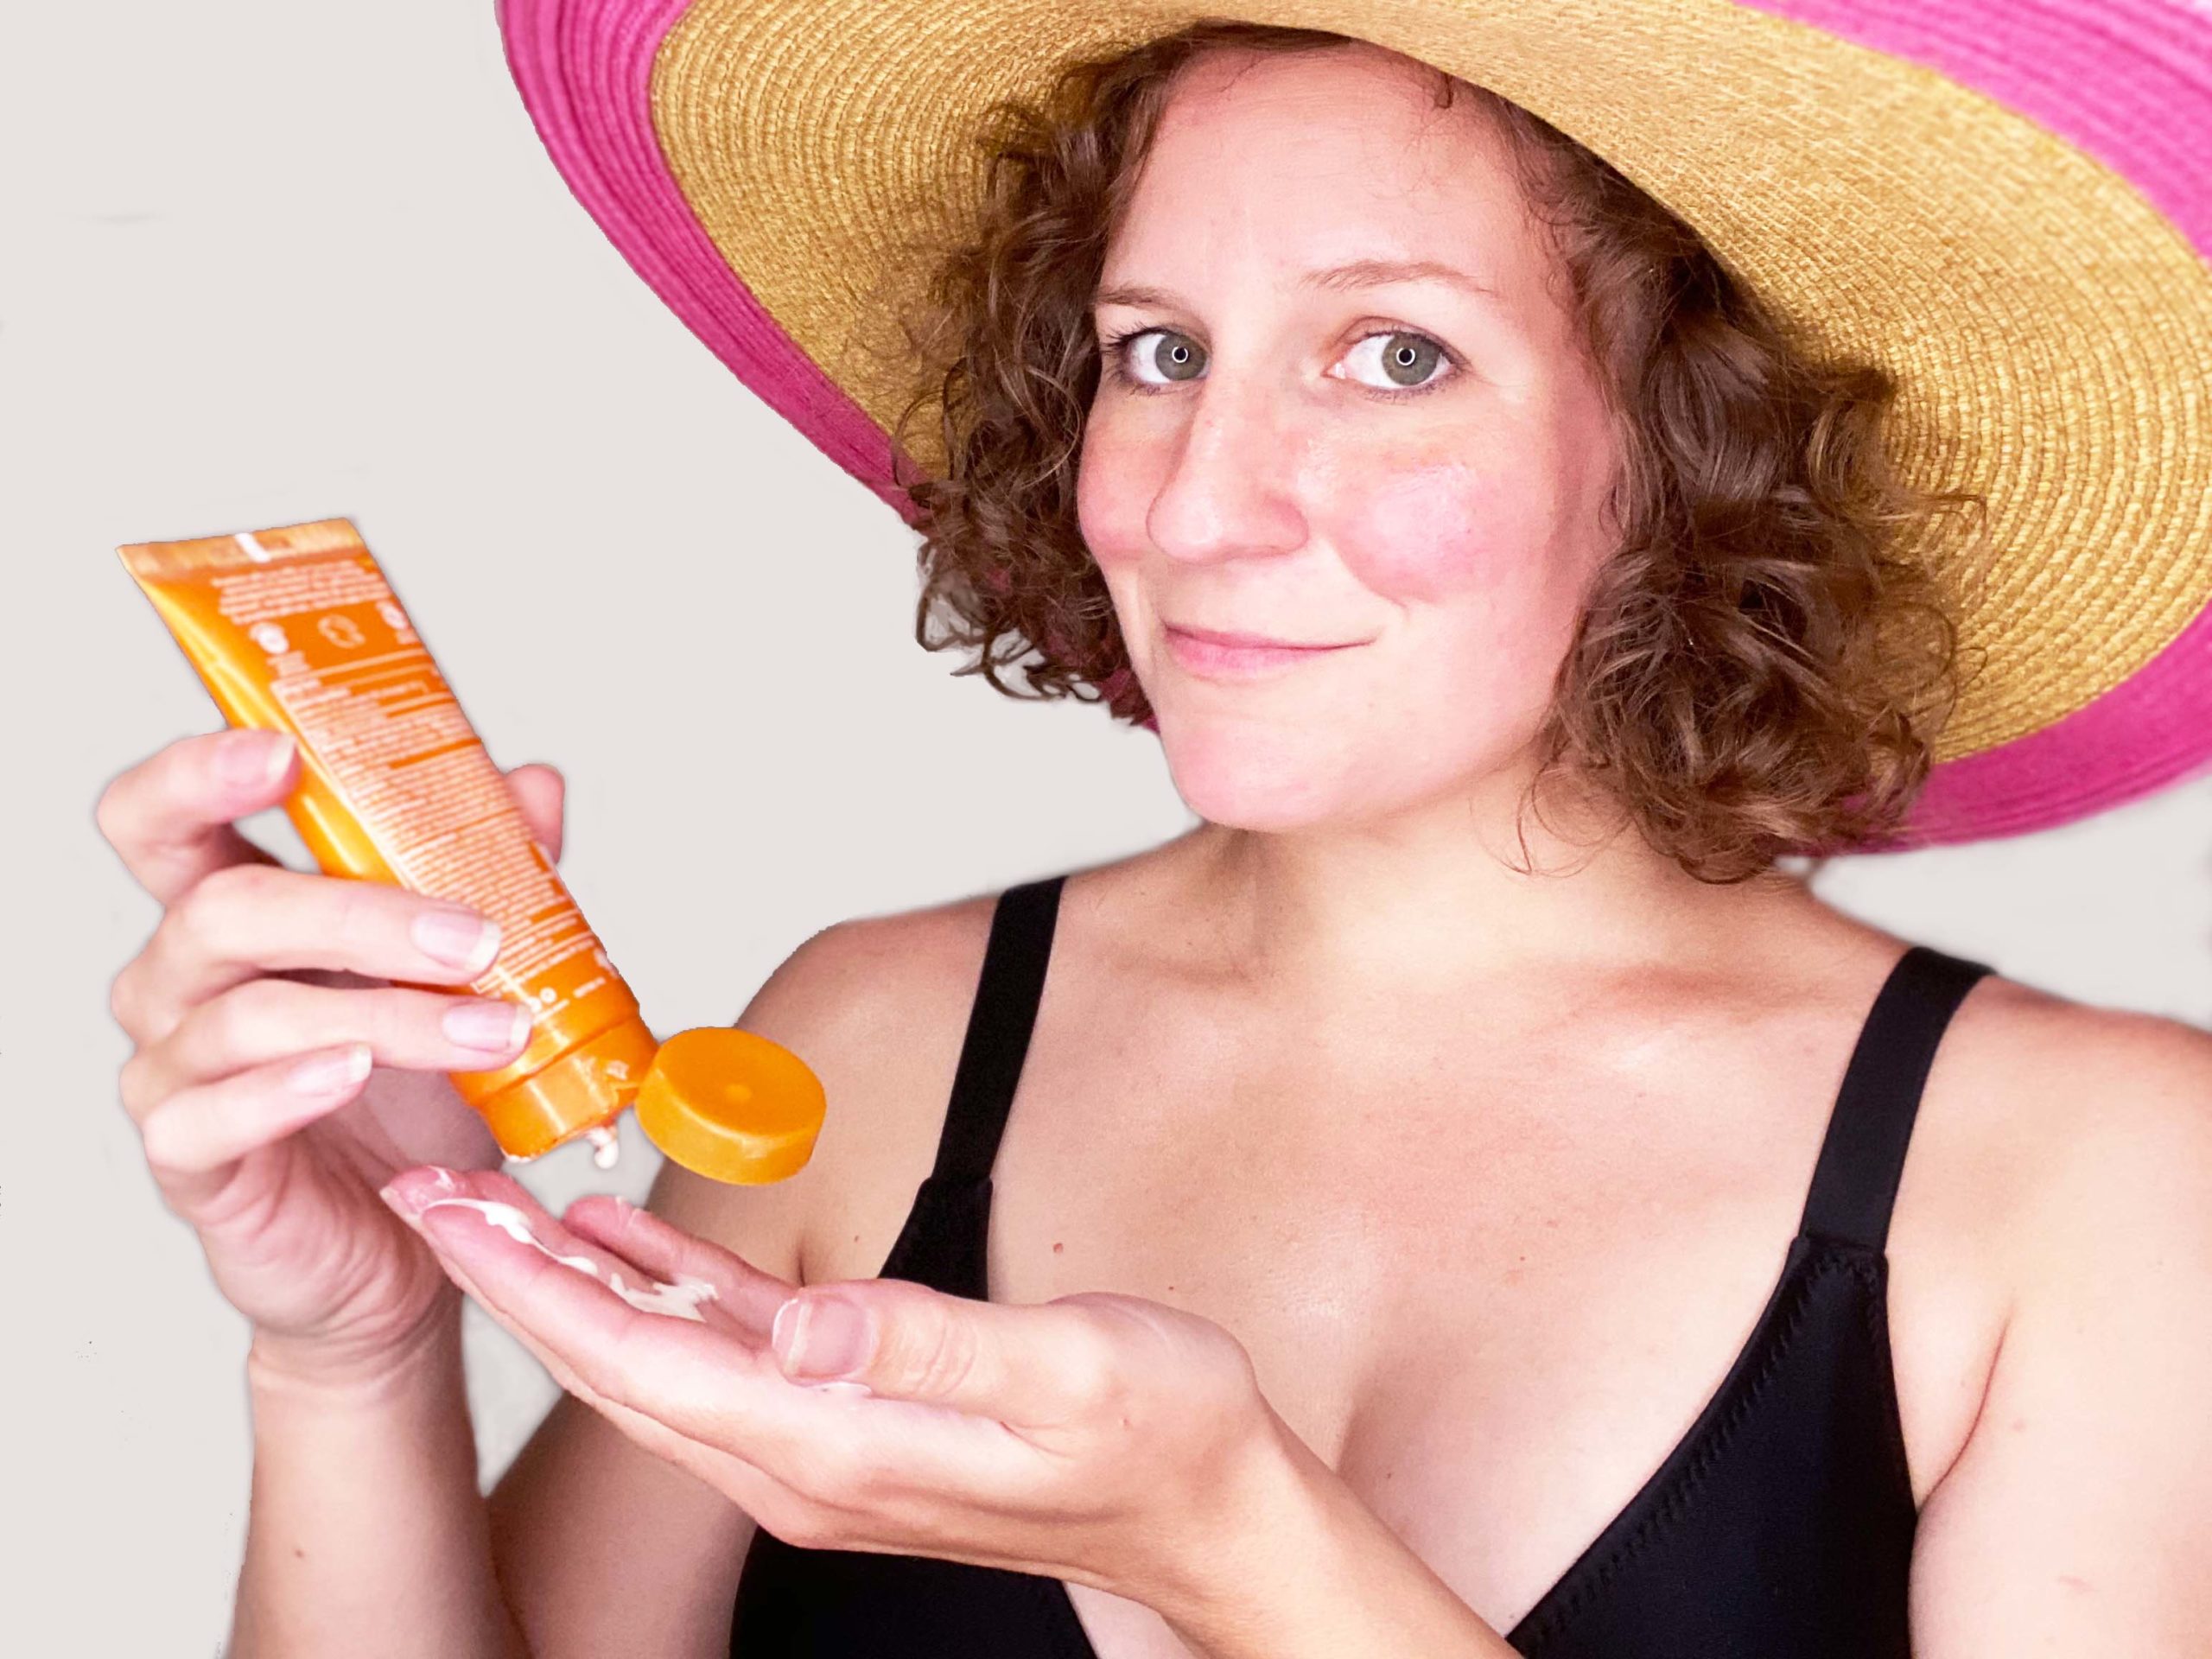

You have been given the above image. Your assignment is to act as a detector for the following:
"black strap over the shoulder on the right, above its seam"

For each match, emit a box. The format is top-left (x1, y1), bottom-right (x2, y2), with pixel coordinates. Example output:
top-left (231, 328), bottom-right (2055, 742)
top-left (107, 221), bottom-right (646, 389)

top-left (1801, 944), bottom-right (1991, 1249)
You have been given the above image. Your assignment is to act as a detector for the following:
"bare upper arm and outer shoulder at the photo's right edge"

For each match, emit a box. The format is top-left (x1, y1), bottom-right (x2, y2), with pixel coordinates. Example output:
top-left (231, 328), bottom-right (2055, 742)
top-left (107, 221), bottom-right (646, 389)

top-left (1911, 1008), bottom-right (2212, 1659)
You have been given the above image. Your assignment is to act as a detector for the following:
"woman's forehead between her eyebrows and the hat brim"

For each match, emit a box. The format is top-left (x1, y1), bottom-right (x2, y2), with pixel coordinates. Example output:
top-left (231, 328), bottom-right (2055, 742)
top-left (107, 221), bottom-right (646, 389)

top-left (1106, 42), bottom-right (1548, 292)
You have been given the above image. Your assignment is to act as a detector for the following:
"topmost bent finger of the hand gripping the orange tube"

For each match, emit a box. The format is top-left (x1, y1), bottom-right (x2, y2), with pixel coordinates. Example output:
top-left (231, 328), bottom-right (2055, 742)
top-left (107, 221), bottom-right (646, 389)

top-left (93, 728), bottom-right (299, 905)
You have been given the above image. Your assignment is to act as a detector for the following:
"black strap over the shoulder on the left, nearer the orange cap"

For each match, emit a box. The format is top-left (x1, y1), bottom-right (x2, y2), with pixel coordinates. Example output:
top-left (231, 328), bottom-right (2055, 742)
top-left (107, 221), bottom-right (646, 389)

top-left (931, 874), bottom-right (1066, 1181)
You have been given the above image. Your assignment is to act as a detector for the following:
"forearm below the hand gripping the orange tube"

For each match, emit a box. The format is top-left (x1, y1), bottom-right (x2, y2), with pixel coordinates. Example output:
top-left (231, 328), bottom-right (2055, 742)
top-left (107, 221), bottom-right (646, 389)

top-left (230, 1300), bottom-right (526, 1659)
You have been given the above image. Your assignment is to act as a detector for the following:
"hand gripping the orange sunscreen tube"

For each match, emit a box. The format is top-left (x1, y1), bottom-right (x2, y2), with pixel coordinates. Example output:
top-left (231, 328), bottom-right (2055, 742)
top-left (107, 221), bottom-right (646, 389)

top-left (95, 730), bottom-right (564, 1380)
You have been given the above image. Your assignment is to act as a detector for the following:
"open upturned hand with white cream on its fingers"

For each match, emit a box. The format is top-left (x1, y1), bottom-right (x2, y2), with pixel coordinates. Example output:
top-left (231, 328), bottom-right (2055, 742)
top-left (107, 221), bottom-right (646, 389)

top-left (385, 1166), bottom-right (1289, 1606)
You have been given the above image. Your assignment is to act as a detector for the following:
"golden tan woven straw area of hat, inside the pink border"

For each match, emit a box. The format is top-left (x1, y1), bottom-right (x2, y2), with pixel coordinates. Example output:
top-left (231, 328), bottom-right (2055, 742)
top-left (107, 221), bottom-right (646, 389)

top-left (652, 0), bottom-right (2212, 759)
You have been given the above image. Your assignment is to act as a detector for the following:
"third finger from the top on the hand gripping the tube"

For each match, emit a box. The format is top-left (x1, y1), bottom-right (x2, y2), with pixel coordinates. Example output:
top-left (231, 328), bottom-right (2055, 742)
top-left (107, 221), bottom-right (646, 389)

top-left (122, 978), bottom-right (531, 1119)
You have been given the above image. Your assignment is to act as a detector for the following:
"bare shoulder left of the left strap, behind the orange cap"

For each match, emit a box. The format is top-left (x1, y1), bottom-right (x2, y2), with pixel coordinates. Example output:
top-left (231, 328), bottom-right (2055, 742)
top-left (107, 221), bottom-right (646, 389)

top-left (652, 892), bottom-right (998, 1283)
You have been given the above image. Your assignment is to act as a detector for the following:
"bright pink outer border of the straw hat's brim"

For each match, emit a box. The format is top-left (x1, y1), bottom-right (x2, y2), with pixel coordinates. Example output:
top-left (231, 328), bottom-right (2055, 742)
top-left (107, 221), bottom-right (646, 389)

top-left (498, 0), bottom-right (2212, 852)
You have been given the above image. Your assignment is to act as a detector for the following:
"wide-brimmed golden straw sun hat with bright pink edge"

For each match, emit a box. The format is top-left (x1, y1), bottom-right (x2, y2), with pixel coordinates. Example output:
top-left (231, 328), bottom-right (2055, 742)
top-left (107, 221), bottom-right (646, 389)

top-left (500, 0), bottom-right (2212, 845)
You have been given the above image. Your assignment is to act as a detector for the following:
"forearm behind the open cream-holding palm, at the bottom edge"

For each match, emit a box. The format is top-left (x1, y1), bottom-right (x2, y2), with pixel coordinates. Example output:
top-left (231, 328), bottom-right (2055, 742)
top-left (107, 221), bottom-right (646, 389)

top-left (1154, 1431), bottom-right (1516, 1659)
